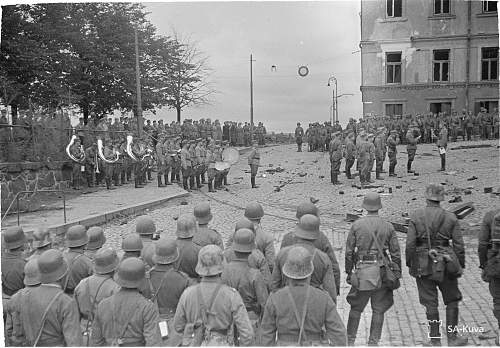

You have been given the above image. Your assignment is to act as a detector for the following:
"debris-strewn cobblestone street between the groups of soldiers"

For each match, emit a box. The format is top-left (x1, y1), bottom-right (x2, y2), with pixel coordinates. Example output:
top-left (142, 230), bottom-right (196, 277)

top-left (102, 141), bottom-right (499, 346)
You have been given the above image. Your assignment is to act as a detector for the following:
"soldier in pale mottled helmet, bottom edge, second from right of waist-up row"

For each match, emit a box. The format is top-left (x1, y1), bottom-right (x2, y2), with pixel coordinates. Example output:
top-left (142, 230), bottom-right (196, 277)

top-left (174, 245), bottom-right (254, 346)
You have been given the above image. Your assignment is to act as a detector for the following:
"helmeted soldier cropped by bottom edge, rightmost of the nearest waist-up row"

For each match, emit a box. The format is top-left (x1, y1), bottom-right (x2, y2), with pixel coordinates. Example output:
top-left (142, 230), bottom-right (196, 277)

top-left (261, 246), bottom-right (347, 346)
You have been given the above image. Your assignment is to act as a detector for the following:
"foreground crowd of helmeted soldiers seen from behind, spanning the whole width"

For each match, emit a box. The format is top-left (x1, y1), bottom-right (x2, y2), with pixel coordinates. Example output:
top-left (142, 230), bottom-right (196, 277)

top-left (1, 185), bottom-right (500, 346)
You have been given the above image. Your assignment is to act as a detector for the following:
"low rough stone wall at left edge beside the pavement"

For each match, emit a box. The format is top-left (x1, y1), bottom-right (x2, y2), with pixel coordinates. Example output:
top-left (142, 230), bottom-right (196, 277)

top-left (0, 161), bottom-right (72, 213)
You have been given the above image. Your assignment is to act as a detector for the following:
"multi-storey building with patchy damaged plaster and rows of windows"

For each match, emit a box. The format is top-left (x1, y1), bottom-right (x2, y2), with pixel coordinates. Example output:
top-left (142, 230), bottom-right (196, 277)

top-left (360, 0), bottom-right (499, 116)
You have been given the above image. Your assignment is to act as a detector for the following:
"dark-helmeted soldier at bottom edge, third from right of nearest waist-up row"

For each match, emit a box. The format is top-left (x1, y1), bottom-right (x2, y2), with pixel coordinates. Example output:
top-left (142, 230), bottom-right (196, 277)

top-left (90, 257), bottom-right (162, 346)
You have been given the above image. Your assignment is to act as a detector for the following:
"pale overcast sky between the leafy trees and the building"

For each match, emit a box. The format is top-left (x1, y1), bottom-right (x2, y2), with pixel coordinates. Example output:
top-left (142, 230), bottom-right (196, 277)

top-left (146, 0), bottom-right (362, 132)
